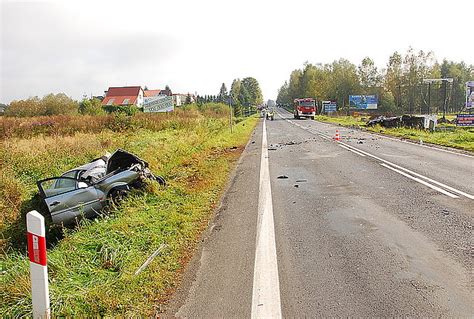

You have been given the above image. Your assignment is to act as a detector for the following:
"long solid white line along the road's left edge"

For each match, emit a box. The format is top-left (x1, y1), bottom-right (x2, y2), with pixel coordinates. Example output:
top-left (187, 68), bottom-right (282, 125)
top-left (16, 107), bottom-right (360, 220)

top-left (251, 120), bottom-right (281, 318)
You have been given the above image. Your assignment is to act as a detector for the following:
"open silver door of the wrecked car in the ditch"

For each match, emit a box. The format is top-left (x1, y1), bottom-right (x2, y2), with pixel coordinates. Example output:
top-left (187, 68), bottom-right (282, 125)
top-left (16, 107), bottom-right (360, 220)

top-left (38, 176), bottom-right (103, 224)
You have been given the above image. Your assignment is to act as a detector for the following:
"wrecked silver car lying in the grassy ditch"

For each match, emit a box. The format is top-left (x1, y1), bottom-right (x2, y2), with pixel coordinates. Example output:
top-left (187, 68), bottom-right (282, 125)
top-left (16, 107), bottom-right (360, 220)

top-left (37, 149), bottom-right (165, 225)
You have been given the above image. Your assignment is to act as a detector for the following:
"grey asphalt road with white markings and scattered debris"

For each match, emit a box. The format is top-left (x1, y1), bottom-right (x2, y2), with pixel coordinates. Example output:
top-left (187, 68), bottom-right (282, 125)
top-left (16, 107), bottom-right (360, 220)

top-left (162, 110), bottom-right (474, 318)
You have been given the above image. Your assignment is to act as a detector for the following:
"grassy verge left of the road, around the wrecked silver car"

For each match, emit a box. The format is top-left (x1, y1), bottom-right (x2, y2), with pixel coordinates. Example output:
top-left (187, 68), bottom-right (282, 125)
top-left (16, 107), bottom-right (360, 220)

top-left (0, 112), bottom-right (257, 317)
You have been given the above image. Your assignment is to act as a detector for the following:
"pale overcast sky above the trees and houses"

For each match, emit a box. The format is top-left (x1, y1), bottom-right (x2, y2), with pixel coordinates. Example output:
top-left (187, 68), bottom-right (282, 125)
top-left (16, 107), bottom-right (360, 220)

top-left (0, 0), bottom-right (474, 103)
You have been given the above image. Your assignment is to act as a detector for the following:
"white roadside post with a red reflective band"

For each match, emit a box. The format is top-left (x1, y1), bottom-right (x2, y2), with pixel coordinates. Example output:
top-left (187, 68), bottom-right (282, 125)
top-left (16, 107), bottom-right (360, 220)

top-left (26, 210), bottom-right (51, 319)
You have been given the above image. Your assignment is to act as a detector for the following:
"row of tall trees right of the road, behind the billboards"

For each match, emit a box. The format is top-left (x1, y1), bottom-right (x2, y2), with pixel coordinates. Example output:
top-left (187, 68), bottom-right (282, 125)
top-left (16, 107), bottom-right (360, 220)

top-left (277, 48), bottom-right (474, 114)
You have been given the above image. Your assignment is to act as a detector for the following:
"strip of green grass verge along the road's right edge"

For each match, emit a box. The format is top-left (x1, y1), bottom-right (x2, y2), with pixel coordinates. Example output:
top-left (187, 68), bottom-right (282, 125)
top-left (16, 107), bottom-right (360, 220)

top-left (316, 115), bottom-right (474, 152)
